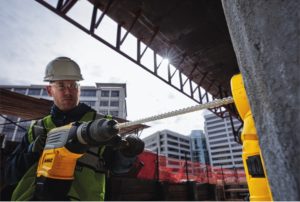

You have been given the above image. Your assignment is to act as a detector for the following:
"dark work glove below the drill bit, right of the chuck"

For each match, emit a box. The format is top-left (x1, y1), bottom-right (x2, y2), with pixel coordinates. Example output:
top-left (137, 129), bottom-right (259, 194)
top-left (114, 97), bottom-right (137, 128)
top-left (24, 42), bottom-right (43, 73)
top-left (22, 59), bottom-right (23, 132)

top-left (120, 135), bottom-right (145, 157)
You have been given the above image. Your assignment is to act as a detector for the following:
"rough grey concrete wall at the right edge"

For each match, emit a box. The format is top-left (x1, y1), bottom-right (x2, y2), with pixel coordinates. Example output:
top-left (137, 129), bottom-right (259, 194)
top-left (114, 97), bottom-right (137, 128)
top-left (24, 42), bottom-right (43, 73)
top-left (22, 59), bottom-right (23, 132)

top-left (222, 0), bottom-right (300, 201)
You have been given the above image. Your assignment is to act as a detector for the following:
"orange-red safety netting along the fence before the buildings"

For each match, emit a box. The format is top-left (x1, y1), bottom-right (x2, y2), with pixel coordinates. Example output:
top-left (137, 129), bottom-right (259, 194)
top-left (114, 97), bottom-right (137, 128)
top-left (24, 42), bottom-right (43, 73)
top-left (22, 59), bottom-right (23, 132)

top-left (137, 151), bottom-right (246, 184)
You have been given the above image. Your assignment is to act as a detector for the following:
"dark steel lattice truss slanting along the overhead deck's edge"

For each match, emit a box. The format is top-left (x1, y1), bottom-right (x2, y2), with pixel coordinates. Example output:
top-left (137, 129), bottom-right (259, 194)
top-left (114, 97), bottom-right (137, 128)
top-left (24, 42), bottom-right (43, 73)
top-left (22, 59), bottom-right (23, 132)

top-left (36, 0), bottom-right (238, 117)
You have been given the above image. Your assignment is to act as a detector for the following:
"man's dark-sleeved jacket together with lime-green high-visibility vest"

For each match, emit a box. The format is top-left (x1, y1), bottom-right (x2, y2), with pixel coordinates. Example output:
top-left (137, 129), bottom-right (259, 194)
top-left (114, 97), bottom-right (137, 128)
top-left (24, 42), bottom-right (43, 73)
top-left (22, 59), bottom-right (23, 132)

top-left (5, 104), bottom-right (134, 201)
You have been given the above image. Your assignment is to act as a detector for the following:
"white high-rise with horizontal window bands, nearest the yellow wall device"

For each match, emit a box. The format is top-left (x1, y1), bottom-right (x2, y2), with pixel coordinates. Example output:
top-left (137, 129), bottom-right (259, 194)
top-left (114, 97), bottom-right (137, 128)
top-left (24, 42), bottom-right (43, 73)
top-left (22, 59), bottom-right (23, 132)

top-left (204, 114), bottom-right (243, 168)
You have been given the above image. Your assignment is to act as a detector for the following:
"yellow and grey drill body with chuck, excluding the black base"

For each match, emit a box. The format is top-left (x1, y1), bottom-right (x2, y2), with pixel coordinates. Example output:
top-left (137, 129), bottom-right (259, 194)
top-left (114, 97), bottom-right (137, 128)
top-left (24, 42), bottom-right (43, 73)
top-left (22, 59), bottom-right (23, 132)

top-left (37, 119), bottom-right (121, 180)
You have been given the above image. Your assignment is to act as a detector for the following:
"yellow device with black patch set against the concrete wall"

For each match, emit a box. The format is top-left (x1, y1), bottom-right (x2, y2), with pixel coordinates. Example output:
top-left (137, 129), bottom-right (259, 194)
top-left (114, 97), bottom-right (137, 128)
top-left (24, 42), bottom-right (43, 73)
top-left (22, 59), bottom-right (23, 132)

top-left (231, 74), bottom-right (273, 201)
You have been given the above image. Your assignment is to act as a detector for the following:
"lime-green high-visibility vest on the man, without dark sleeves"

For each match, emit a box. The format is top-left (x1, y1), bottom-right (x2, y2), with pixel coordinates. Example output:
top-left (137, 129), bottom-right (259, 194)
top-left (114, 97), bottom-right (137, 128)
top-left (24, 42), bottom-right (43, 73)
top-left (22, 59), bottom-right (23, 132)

top-left (12, 111), bottom-right (105, 201)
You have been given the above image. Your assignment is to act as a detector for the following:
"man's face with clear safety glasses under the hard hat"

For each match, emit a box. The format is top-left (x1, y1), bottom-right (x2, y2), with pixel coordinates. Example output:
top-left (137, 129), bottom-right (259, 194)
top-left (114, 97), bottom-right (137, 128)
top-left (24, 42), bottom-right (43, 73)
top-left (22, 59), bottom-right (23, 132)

top-left (46, 80), bottom-right (80, 112)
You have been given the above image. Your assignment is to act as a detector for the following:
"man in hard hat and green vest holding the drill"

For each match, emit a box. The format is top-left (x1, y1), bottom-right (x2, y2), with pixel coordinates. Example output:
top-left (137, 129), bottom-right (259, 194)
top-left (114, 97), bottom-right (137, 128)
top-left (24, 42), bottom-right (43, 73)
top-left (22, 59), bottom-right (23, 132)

top-left (5, 57), bottom-right (144, 201)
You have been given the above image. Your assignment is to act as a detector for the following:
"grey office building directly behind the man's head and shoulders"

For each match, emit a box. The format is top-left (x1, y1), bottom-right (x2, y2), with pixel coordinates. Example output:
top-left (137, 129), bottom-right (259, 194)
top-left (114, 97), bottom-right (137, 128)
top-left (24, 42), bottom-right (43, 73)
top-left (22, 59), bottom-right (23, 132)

top-left (0, 83), bottom-right (127, 142)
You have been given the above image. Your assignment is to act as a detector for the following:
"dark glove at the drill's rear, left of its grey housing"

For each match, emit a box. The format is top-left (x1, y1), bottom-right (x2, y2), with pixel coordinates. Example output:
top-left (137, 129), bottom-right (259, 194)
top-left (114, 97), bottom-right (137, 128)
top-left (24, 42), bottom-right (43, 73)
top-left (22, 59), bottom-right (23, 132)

top-left (31, 125), bottom-right (47, 153)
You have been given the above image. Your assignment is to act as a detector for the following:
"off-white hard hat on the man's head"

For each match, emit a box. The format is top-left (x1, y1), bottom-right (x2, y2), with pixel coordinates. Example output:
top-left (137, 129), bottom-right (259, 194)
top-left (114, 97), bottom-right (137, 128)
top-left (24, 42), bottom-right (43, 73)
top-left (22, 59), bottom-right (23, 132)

top-left (44, 57), bottom-right (83, 81)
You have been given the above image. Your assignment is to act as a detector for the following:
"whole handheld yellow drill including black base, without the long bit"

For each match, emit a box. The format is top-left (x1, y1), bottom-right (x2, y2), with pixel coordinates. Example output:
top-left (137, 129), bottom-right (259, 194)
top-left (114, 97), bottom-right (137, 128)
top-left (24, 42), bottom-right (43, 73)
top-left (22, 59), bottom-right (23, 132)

top-left (35, 119), bottom-right (122, 200)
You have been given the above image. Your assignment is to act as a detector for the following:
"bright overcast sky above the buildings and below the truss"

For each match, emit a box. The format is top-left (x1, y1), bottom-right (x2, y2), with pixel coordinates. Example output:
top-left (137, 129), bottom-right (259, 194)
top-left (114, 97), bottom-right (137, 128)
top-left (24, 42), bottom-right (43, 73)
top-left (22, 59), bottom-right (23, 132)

top-left (0, 0), bottom-right (210, 137)
